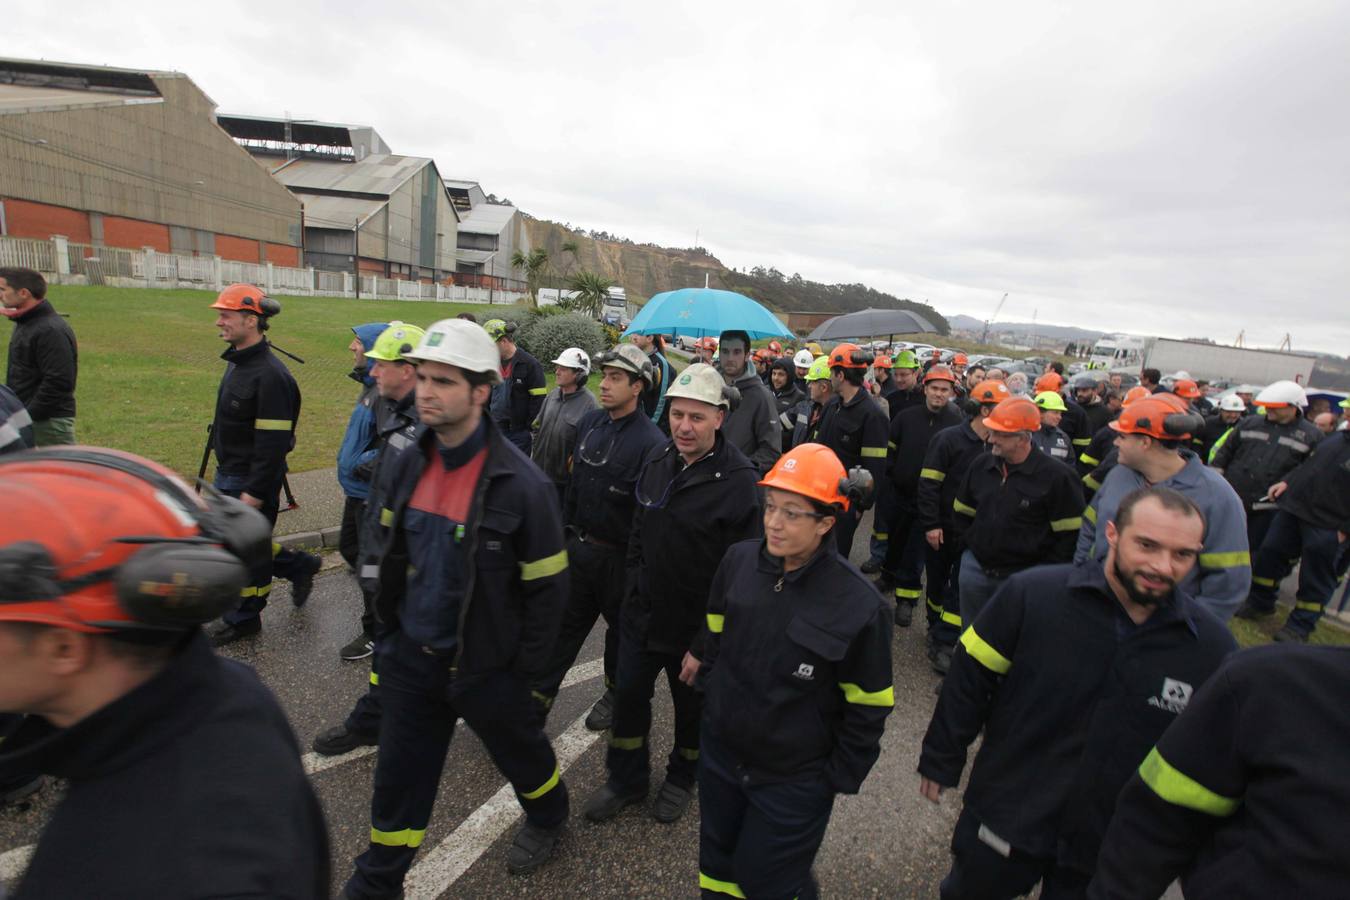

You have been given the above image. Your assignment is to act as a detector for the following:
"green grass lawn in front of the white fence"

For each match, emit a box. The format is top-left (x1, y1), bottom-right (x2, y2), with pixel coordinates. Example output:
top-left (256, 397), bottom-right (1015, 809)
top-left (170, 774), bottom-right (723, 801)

top-left (0, 285), bottom-right (526, 476)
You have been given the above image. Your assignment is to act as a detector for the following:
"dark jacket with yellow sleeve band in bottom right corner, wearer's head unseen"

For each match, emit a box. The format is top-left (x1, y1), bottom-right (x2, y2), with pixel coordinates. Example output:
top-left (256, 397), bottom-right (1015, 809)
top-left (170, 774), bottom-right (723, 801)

top-left (1088, 644), bottom-right (1350, 900)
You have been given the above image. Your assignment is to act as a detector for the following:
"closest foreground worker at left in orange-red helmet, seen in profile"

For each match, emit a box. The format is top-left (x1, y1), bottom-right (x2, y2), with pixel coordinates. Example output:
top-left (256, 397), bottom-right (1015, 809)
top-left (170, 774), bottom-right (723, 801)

top-left (0, 447), bottom-right (331, 900)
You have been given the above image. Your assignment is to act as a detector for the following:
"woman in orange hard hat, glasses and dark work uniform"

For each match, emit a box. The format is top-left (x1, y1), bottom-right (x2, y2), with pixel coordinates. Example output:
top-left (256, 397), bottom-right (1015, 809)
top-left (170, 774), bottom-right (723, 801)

top-left (680, 444), bottom-right (894, 899)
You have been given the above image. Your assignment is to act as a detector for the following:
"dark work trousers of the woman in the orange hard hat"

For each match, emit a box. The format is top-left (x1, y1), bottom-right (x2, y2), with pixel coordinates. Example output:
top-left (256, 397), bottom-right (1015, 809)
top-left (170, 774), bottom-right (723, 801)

top-left (698, 727), bottom-right (834, 900)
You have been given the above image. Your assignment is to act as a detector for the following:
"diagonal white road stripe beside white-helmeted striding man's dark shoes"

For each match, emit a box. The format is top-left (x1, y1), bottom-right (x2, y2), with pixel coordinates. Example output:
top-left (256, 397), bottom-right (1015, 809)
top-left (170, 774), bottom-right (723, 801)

top-left (404, 710), bottom-right (599, 900)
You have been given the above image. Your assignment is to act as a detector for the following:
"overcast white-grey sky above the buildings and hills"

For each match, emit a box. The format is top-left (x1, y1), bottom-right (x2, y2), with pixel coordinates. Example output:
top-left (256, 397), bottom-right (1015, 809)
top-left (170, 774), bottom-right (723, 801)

top-left (13, 0), bottom-right (1350, 355)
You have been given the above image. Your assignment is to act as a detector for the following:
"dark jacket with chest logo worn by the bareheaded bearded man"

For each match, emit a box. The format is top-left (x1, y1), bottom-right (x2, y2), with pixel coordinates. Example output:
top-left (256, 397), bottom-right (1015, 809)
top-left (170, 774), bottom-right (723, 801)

top-left (919, 561), bottom-right (1237, 873)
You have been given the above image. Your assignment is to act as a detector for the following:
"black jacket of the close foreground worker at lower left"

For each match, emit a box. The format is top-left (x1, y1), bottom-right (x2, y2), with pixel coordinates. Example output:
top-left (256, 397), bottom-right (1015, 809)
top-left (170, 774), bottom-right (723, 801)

top-left (0, 631), bottom-right (331, 900)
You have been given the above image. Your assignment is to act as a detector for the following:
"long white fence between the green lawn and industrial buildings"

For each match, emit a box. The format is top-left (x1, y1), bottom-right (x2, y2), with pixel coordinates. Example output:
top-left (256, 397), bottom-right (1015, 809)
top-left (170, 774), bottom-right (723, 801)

top-left (0, 236), bottom-right (525, 304)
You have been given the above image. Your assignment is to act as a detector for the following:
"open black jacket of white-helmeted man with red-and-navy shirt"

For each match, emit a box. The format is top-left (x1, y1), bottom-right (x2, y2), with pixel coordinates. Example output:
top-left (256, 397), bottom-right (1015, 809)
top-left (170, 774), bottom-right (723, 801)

top-left (360, 416), bottom-right (568, 681)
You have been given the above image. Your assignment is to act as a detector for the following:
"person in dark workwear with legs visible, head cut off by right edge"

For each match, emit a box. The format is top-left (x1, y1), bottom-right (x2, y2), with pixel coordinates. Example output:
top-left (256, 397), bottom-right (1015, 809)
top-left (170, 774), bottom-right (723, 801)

top-left (1238, 430), bottom-right (1350, 644)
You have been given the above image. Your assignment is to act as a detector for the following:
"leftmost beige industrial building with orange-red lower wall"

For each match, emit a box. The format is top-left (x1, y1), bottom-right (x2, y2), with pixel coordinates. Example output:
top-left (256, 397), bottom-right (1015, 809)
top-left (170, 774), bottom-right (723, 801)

top-left (0, 59), bottom-right (301, 266)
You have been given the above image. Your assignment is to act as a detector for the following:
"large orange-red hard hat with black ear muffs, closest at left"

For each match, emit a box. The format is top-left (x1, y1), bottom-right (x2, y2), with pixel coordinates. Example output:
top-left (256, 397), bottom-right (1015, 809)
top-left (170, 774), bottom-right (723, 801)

top-left (0, 447), bottom-right (271, 633)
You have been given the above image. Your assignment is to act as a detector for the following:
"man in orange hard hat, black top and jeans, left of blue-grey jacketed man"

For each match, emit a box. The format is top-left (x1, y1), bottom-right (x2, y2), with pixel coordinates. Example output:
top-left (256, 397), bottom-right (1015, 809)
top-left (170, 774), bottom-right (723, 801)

top-left (944, 397), bottom-right (1083, 625)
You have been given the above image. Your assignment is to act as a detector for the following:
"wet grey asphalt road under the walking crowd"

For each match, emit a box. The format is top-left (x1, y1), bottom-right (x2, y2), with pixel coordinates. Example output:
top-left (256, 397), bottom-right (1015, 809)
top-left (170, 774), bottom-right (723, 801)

top-left (0, 512), bottom-right (959, 900)
